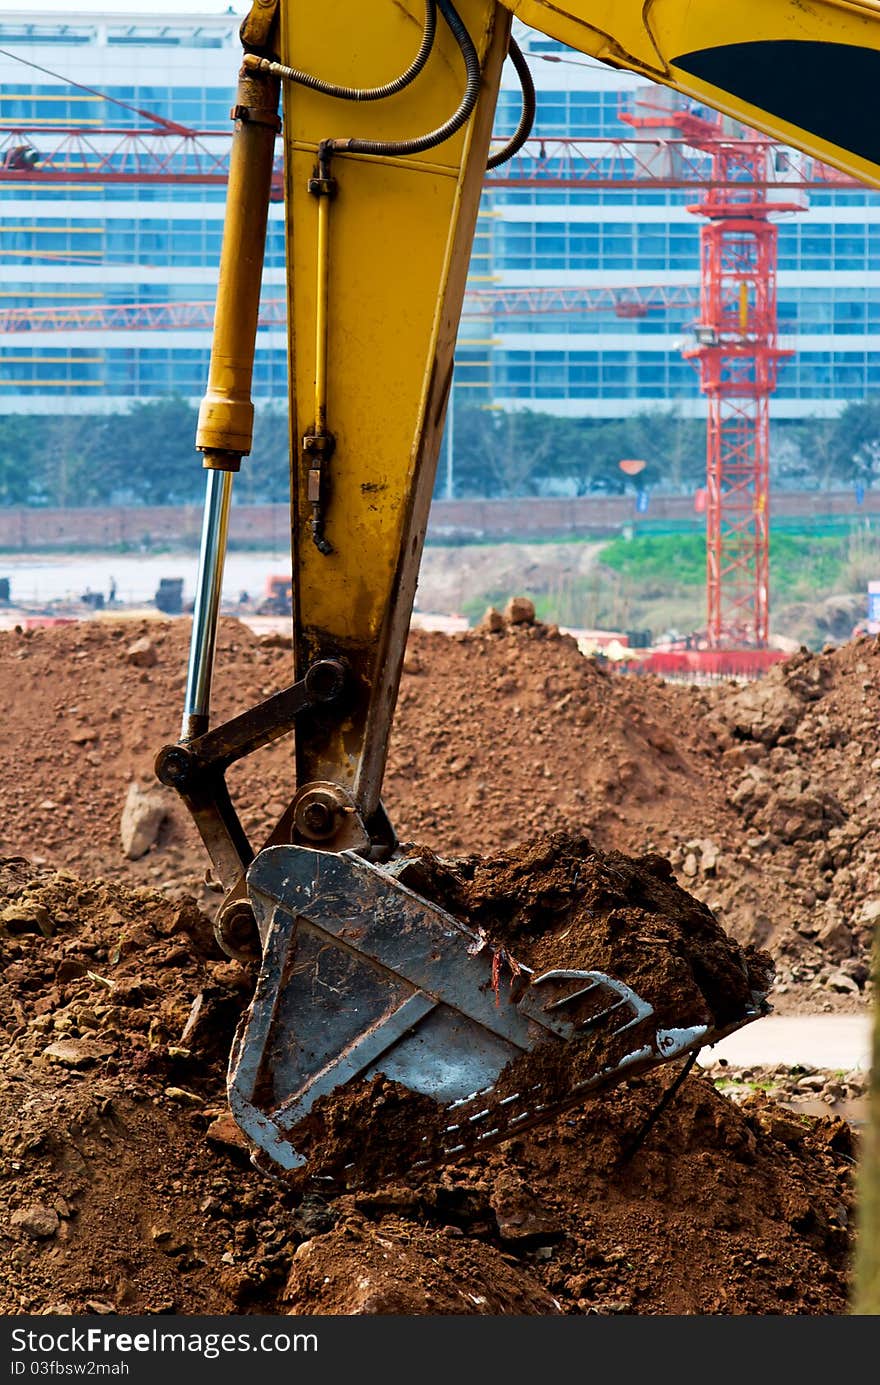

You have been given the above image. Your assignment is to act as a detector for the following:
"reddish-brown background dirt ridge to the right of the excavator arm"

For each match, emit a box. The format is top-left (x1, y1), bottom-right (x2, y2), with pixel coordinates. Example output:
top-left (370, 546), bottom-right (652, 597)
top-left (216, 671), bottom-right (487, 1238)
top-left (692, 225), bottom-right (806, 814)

top-left (385, 625), bottom-right (880, 1012)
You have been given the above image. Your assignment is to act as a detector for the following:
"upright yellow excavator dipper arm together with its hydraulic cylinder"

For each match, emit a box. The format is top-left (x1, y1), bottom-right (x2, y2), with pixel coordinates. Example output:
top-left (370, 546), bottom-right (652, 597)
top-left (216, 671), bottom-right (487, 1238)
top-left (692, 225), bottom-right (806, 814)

top-left (159, 0), bottom-right (510, 932)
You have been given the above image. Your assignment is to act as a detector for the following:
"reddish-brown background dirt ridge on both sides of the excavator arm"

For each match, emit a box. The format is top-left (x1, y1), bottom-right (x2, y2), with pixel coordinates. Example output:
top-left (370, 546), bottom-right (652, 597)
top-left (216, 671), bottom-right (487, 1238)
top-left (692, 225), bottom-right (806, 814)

top-left (0, 619), bottom-right (880, 1012)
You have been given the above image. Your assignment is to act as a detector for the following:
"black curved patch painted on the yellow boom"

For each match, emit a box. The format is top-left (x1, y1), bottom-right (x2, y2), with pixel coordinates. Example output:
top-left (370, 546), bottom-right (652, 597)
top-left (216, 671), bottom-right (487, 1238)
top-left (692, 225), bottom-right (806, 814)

top-left (674, 39), bottom-right (880, 163)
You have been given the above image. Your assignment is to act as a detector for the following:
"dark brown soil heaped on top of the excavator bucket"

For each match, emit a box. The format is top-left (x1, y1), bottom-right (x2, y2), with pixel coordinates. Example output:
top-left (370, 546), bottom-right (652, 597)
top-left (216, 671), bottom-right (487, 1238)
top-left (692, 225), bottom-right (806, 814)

top-left (401, 832), bottom-right (772, 1029)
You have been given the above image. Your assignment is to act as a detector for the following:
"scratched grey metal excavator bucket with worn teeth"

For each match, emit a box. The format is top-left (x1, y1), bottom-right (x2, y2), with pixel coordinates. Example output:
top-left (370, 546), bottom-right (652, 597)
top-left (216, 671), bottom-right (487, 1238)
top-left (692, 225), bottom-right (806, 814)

top-left (229, 846), bottom-right (766, 1169)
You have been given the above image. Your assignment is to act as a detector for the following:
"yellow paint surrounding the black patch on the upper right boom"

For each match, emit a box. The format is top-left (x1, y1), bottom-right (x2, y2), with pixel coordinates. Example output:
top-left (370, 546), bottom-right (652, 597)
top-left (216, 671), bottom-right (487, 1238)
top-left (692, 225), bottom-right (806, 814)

top-left (502, 0), bottom-right (880, 187)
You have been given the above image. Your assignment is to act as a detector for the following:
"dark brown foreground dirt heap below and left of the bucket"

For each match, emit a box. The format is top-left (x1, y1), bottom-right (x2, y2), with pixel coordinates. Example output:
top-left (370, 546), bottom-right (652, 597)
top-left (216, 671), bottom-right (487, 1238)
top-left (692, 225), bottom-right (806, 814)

top-left (0, 839), bottom-right (856, 1314)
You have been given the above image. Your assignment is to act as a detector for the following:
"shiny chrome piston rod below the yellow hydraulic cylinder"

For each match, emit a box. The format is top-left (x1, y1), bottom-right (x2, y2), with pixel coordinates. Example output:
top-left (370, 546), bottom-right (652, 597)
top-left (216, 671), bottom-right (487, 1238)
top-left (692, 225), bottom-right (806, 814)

top-left (180, 470), bottom-right (234, 741)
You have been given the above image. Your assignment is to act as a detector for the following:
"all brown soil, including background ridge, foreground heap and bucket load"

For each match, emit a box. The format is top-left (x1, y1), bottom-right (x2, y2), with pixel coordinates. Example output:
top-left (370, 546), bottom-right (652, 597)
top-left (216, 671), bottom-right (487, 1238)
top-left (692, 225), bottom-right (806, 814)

top-left (0, 620), bottom-right (880, 1314)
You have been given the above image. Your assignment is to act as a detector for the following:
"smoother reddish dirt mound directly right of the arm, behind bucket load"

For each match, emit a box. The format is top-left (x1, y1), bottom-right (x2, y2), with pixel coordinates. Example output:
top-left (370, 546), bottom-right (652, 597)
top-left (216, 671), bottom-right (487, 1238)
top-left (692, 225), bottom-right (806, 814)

top-left (385, 625), bottom-right (728, 852)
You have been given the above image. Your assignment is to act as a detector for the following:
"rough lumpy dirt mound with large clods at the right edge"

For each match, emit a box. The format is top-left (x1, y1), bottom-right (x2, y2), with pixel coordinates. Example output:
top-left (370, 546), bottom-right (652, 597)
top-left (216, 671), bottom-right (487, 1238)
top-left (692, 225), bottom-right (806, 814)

top-left (695, 638), bottom-right (880, 1010)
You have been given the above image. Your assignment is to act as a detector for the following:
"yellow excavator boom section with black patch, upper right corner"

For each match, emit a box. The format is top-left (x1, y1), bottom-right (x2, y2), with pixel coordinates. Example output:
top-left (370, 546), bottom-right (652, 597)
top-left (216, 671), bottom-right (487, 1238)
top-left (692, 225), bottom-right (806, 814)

top-left (504, 0), bottom-right (880, 184)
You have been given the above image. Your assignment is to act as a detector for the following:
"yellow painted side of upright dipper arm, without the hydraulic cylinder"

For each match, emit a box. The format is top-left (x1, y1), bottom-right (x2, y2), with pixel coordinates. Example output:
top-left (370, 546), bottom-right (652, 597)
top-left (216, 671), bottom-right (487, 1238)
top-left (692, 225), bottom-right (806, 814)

top-left (279, 0), bottom-right (510, 813)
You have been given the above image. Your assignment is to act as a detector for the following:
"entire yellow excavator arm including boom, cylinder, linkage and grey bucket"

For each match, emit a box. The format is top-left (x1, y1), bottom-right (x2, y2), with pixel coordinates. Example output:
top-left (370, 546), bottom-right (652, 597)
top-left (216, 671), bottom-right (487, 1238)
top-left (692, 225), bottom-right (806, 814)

top-left (157, 0), bottom-right (880, 1168)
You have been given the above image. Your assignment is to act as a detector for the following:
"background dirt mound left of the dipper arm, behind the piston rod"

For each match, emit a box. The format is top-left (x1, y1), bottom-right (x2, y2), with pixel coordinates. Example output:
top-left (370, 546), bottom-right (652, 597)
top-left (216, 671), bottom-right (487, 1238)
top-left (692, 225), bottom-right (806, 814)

top-left (0, 620), bottom-right (292, 906)
